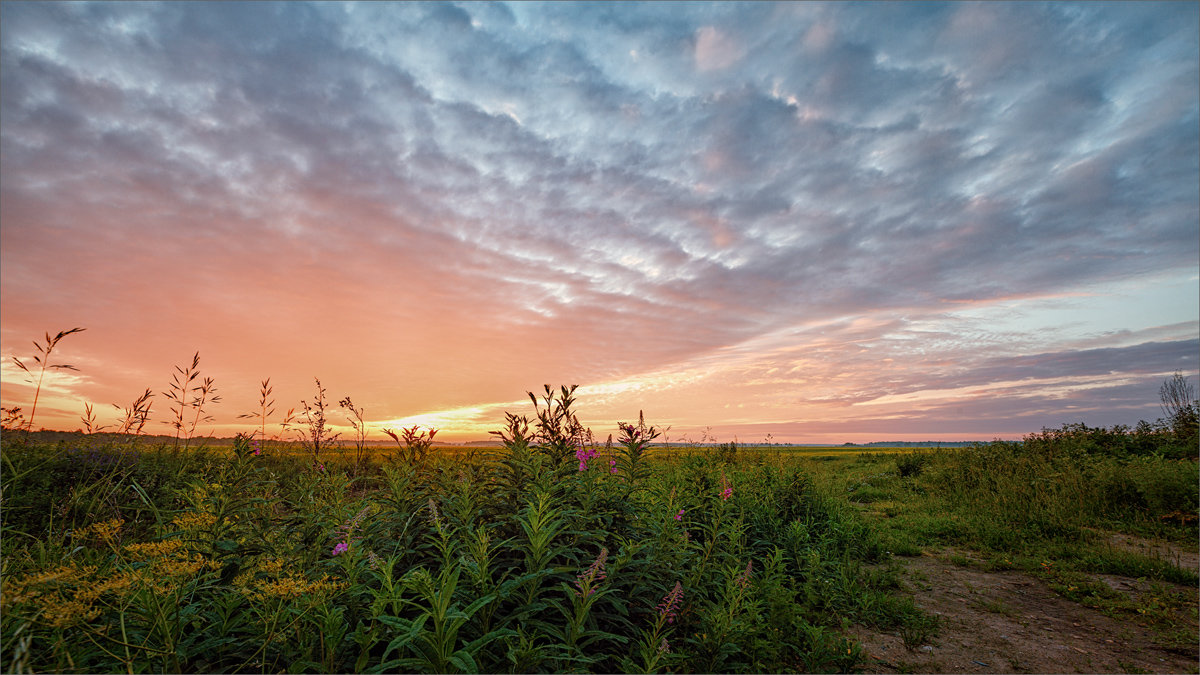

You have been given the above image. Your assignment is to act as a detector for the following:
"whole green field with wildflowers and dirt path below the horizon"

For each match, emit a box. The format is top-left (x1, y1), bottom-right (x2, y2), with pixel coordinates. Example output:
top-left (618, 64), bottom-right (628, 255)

top-left (0, 396), bottom-right (1198, 673)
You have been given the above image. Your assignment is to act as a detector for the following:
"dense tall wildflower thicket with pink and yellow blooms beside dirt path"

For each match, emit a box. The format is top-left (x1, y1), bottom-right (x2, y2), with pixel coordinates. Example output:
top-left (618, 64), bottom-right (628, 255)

top-left (0, 375), bottom-right (974, 673)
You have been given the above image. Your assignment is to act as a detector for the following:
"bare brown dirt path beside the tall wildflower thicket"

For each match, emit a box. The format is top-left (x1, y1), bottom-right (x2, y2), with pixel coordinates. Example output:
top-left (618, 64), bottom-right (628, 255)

top-left (852, 551), bottom-right (1200, 673)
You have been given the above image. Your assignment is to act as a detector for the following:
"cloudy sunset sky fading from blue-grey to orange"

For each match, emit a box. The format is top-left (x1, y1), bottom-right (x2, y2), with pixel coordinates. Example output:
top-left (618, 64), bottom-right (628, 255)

top-left (0, 1), bottom-right (1200, 443)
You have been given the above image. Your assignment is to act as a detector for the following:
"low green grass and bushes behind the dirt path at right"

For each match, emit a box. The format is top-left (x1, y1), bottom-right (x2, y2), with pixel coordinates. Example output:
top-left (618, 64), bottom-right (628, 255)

top-left (782, 428), bottom-right (1200, 646)
